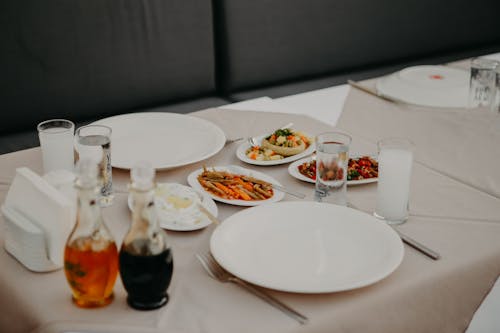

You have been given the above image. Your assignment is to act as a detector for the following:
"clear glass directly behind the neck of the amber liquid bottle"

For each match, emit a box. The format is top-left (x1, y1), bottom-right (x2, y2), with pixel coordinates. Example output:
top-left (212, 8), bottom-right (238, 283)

top-left (75, 125), bottom-right (113, 206)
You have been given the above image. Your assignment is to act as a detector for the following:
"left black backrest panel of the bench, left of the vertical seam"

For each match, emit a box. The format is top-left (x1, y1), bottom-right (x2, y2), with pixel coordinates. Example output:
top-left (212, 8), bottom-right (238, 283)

top-left (0, 0), bottom-right (215, 133)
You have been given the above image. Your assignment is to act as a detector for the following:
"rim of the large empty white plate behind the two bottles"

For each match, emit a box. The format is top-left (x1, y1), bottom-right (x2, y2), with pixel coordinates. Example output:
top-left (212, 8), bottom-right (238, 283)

top-left (89, 111), bottom-right (226, 170)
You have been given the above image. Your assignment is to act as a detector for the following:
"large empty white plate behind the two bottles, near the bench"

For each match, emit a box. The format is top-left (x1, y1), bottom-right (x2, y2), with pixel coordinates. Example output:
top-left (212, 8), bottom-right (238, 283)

top-left (94, 112), bottom-right (226, 169)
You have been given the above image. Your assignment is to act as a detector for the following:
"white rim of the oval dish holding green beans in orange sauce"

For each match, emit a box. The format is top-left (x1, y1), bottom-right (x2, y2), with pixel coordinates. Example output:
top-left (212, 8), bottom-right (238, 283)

top-left (187, 165), bottom-right (285, 206)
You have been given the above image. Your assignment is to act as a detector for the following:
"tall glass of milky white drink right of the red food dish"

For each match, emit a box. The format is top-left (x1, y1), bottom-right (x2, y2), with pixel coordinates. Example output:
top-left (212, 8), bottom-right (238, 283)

top-left (374, 138), bottom-right (414, 224)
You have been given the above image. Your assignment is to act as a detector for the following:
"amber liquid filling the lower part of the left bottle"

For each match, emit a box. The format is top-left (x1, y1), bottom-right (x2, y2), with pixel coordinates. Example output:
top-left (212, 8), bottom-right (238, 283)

top-left (64, 238), bottom-right (118, 308)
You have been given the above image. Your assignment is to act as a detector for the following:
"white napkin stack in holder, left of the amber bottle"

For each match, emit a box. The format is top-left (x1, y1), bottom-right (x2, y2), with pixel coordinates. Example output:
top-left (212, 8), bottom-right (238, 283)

top-left (2, 167), bottom-right (75, 272)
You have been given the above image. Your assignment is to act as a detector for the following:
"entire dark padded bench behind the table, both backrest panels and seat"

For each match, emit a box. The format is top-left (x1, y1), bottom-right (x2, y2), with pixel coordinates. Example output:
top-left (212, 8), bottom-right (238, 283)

top-left (0, 0), bottom-right (500, 154)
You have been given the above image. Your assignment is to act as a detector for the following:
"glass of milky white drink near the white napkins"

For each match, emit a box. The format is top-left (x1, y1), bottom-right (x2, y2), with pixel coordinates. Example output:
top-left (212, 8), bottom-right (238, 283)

top-left (37, 119), bottom-right (75, 174)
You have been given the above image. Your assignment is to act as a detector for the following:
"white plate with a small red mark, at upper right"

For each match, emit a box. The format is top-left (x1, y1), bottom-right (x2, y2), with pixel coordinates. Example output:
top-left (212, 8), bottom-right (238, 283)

top-left (376, 66), bottom-right (470, 108)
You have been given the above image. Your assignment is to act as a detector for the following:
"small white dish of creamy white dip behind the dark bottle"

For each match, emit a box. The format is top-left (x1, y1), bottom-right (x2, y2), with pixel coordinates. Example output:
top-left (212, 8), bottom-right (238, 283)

top-left (128, 183), bottom-right (218, 231)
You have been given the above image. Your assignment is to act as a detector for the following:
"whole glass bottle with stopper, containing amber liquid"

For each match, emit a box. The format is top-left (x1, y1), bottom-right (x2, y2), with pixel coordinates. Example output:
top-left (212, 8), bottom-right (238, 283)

top-left (64, 160), bottom-right (118, 308)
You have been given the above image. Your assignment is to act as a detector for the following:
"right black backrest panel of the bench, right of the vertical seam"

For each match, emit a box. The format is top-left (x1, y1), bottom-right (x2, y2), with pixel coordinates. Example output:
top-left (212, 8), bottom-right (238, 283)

top-left (214, 0), bottom-right (500, 92)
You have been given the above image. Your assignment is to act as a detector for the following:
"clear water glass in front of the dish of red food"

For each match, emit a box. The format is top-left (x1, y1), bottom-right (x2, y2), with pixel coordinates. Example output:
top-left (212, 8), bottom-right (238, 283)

top-left (314, 132), bottom-right (351, 206)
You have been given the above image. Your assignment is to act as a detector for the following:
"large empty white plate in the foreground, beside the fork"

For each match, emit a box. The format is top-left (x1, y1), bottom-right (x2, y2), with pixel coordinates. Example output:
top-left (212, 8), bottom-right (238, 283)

top-left (210, 201), bottom-right (404, 293)
